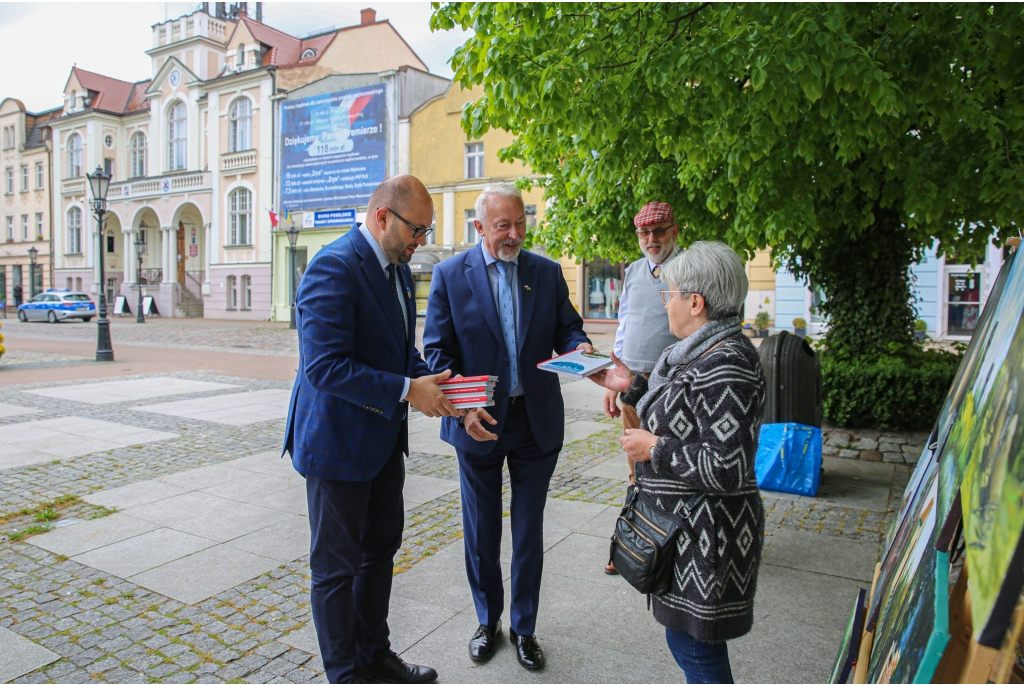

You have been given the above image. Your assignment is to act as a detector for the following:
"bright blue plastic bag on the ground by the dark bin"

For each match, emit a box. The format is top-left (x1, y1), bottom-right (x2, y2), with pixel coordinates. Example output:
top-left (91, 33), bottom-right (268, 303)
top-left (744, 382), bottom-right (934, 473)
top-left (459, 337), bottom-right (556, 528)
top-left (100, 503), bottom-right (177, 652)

top-left (754, 423), bottom-right (821, 497)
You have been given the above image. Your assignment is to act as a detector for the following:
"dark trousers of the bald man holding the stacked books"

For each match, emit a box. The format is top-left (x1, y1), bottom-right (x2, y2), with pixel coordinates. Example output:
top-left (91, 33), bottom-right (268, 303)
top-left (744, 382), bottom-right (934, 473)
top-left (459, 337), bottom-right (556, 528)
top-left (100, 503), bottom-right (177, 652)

top-left (306, 440), bottom-right (406, 683)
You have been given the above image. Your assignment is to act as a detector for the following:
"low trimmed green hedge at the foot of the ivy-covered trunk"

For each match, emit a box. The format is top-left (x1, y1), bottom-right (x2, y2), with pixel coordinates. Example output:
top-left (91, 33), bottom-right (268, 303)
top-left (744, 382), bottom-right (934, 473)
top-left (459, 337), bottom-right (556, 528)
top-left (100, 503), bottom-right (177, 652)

top-left (821, 350), bottom-right (962, 430)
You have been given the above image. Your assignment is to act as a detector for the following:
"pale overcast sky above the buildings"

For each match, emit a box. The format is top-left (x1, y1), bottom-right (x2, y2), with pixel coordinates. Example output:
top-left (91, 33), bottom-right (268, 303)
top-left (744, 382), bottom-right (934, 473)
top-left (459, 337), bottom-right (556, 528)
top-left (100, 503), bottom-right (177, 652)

top-left (0, 0), bottom-right (465, 112)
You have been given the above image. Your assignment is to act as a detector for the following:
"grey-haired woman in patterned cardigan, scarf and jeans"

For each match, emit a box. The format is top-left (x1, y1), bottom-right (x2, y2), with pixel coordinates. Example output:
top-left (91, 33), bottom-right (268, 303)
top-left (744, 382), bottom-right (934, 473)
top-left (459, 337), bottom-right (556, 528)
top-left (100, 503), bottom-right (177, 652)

top-left (591, 242), bottom-right (765, 683)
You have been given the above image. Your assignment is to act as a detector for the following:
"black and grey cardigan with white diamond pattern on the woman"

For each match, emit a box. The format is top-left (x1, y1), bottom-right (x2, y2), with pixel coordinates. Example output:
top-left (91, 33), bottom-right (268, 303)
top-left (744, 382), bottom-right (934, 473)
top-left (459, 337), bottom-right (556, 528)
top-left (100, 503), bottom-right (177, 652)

top-left (637, 333), bottom-right (765, 642)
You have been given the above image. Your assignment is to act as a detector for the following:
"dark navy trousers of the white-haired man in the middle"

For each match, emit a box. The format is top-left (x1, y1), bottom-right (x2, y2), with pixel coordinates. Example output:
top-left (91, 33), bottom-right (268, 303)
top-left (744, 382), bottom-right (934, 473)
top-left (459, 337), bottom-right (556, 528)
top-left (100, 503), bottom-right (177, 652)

top-left (458, 404), bottom-right (559, 635)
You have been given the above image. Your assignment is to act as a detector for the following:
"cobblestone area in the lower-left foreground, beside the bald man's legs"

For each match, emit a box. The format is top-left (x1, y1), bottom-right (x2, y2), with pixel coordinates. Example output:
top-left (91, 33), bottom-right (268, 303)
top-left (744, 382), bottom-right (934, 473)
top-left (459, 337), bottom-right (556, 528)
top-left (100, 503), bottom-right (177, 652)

top-left (0, 543), bottom-right (325, 683)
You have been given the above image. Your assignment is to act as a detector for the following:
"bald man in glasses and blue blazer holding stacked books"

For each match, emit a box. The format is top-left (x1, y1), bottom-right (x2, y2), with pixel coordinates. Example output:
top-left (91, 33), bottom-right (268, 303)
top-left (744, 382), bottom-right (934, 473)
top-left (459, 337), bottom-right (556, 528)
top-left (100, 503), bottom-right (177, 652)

top-left (285, 176), bottom-right (459, 683)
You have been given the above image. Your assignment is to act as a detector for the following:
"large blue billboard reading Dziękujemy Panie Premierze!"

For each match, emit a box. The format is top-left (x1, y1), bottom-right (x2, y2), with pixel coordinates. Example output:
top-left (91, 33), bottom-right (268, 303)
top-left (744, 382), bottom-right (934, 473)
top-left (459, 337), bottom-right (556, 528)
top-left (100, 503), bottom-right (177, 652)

top-left (281, 84), bottom-right (387, 212)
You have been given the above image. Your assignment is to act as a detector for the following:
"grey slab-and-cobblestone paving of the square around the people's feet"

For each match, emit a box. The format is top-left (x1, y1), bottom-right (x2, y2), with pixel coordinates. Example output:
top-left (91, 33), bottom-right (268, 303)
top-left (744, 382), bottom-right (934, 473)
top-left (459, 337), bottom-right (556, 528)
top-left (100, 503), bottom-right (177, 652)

top-left (0, 326), bottom-right (897, 682)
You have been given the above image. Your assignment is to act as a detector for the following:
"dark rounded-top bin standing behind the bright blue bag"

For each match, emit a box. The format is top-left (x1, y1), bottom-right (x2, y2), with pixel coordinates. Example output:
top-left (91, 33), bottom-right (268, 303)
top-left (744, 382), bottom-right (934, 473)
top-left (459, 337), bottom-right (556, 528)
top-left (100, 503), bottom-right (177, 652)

top-left (758, 331), bottom-right (822, 428)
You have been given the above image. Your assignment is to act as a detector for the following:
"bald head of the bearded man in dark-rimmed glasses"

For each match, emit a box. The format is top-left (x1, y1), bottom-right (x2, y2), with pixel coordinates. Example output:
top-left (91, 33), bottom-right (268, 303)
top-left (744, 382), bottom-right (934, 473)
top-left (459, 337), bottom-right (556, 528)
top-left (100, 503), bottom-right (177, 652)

top-left (367, 174), bottom-right (434, 264)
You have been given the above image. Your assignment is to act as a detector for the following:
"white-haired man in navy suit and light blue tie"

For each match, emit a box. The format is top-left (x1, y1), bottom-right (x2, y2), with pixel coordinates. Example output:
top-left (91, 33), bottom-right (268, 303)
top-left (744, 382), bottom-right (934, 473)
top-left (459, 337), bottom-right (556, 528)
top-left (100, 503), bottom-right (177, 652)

top-left (423, 185), bottom-right (593, 670)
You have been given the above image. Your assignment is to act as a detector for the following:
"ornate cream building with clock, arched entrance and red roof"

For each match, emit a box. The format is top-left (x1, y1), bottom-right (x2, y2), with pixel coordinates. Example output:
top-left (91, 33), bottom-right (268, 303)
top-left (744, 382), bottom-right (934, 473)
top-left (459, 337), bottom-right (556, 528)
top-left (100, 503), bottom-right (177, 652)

top-left (51, 3), bottom-right (422, 319)
